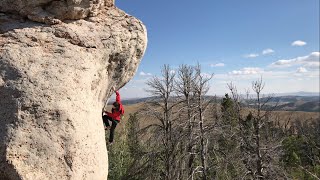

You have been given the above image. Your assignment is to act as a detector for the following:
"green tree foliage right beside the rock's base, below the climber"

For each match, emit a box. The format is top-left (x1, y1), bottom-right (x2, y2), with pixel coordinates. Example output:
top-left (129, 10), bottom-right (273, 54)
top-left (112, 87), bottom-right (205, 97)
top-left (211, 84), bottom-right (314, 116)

top-left (106, 113), bottom-right (159, 180)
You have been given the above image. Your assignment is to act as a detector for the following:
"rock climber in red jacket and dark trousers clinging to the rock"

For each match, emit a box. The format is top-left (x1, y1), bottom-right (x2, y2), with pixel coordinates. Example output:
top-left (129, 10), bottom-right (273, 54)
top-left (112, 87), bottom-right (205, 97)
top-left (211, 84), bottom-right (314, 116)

top-left (102, 87), bottom-right (124, 145)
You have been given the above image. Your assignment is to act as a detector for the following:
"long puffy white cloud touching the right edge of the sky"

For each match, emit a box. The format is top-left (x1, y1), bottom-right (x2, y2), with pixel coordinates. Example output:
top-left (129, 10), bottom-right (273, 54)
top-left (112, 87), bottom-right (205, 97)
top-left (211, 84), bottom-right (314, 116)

top-left (270, 52), bottom-right (320, 68)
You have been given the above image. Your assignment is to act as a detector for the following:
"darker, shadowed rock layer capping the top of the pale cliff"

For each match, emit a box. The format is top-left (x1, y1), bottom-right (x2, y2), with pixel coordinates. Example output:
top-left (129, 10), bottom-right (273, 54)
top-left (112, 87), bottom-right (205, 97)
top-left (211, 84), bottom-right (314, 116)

top-left (0, 0), bottom-right (114, 24)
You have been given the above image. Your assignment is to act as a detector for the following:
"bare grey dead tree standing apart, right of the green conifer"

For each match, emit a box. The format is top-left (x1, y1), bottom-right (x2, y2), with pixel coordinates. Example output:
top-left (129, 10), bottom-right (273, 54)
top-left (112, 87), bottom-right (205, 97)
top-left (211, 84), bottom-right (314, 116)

top-left (229, 78), bottom-right (283, 179)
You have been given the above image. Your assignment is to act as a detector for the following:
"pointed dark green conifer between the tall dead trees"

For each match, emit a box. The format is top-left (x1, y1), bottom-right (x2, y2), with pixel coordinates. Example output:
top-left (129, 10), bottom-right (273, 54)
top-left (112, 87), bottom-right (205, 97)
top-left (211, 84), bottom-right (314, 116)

top-left (208, 94), bottom-right (241, 180)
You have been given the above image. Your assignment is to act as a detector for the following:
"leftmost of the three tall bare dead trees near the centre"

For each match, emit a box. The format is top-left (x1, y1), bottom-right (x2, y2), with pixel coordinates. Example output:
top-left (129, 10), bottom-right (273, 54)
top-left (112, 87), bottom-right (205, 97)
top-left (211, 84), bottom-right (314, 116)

top-left (146, 65), bottom-right (176, 180)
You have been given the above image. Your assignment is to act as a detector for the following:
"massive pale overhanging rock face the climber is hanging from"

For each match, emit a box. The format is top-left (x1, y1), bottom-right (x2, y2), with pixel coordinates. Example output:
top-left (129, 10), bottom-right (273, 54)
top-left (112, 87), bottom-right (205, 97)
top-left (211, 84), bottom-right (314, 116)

top-left (0, 0), bottom-right (147, 180)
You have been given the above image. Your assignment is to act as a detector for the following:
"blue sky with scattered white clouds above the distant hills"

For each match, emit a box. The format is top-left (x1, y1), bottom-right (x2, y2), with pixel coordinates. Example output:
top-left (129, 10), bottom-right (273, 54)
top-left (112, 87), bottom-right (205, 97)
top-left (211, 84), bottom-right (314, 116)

top-left (116, 0), bottom-right (319, 98)
